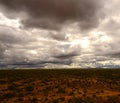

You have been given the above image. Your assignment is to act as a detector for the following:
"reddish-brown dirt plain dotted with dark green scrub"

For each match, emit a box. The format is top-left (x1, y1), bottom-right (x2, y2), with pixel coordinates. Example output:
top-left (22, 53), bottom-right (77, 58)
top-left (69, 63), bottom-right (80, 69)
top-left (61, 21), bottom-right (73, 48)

top-left (0, 69), bottom-right (120, 103)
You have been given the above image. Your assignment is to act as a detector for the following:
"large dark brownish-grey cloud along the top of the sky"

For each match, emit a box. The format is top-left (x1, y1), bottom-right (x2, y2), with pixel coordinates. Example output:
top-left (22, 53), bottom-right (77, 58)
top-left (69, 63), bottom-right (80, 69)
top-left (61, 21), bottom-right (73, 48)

top-left (0, 0), bottom-right (102, 29)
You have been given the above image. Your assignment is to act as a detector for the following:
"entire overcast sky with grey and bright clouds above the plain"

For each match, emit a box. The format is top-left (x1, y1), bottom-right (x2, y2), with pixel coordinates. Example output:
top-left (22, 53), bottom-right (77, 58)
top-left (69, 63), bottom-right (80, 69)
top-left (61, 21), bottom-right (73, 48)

top-left (0, 0), bottom-right (120, 68)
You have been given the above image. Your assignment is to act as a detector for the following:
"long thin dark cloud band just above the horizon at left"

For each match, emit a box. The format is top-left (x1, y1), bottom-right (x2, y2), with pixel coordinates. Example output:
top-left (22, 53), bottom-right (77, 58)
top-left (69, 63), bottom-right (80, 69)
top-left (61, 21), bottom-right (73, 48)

top-left (0, 60), bottom-right (72, 69)
